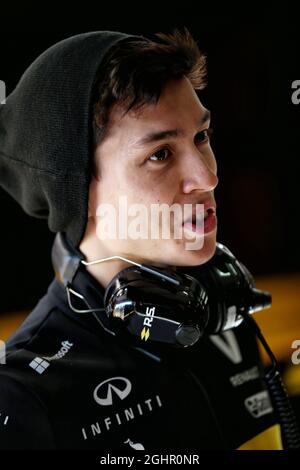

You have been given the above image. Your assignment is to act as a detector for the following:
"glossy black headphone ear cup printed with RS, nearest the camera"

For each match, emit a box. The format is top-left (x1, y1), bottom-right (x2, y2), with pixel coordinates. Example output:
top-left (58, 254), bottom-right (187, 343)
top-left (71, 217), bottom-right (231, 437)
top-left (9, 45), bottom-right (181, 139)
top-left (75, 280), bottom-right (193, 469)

top-left (104, 267), bottom-right (207, 346)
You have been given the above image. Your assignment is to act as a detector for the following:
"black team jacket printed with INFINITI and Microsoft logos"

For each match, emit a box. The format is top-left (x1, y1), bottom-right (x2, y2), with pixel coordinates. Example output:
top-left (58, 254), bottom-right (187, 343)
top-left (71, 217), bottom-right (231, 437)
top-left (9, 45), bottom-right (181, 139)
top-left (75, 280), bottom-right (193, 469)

top-left (0, 269), bottom-right (276, 453)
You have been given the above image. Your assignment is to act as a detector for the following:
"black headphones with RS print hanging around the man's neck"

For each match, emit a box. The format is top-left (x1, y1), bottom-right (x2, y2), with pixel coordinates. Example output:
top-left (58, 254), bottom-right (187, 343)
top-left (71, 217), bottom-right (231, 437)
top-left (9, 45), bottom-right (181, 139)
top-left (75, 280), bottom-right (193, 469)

top-left (52, 233), bottom-right (271, 347)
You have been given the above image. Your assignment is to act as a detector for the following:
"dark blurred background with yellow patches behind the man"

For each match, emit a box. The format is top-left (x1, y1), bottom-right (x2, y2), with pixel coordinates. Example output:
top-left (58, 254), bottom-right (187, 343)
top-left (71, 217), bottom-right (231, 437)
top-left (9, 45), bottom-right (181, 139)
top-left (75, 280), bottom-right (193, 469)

top-left (0, 0), bottom-right (300, 426)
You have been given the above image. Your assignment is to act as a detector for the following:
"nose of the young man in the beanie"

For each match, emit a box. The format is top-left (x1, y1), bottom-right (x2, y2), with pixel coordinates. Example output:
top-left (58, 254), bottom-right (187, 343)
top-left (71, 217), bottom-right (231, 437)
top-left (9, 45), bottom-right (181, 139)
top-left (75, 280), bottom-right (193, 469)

top-left (183, 151), bottom-right (219, 193)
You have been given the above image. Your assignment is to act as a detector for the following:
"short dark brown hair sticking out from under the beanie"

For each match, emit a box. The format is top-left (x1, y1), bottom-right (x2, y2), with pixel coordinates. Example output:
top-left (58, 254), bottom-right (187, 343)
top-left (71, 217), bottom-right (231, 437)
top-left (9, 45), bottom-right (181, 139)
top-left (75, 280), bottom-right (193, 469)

top-left (93, 29), bottom-right (206, 146)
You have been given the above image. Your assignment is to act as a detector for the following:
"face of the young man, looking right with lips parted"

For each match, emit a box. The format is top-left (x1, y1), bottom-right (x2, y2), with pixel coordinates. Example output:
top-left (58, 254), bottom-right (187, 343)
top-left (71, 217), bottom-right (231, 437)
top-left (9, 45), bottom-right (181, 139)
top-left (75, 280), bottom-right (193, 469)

top-left (89, 78), bottom-right (218, 266)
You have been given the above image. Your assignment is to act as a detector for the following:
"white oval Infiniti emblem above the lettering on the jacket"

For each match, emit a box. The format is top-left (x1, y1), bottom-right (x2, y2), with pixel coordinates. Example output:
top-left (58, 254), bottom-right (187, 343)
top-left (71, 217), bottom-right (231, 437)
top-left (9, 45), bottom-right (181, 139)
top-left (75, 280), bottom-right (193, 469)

top-left (94, 377), bottom-right (131, 406)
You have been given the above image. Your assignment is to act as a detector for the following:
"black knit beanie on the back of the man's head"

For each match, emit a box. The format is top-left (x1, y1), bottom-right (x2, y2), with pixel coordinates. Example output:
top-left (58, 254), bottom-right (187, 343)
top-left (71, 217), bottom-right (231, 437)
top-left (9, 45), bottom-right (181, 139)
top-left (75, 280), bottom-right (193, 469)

top-left (0, 31), bottom-right (135, 247)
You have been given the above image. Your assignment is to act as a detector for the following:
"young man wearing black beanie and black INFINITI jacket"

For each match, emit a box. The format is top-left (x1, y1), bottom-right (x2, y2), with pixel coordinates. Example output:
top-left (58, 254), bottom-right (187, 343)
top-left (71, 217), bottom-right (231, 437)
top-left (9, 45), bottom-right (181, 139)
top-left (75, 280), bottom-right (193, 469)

top-left (0, 27), bottom-right (281, 452)
